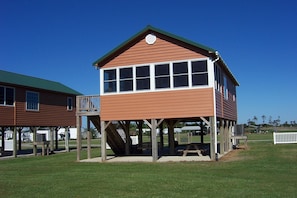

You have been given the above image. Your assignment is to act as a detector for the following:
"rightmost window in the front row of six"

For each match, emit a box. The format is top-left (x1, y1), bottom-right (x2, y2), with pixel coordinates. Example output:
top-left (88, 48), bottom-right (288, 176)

top-left (192, 60), bottom-right (208, 86)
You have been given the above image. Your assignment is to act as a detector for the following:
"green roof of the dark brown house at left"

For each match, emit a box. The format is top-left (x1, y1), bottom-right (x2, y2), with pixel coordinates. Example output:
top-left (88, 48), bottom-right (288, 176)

top-left (0, 70), bottom-right (82, 95)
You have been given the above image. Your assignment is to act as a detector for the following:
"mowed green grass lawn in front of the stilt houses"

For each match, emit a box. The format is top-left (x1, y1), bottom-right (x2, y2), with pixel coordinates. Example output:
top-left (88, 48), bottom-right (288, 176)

top-left (0, 134), bottom-right (297, 198)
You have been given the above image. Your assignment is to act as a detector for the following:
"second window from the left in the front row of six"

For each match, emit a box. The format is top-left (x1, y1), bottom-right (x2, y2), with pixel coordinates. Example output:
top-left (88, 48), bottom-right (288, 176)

top-left (120, 67), bottom-right (133, 91)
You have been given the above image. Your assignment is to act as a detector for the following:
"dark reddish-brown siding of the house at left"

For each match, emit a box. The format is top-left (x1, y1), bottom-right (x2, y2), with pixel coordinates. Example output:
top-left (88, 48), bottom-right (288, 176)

top-left (0, 87), bottom-right (76, 126)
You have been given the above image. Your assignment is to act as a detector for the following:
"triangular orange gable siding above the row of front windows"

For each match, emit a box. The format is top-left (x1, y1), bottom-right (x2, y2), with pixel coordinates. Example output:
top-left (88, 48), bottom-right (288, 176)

top-left (102, 35), bottom-right (206, 68)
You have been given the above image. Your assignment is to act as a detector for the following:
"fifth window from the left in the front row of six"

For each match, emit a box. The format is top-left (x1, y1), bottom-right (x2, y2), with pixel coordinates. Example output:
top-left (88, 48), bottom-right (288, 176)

top-left (173, 62), bottom-right (189, 87)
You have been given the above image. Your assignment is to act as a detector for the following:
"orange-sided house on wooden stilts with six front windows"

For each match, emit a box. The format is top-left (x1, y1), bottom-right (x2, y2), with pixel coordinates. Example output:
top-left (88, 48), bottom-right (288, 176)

top-left (77, 26), bottom-right (239, 162)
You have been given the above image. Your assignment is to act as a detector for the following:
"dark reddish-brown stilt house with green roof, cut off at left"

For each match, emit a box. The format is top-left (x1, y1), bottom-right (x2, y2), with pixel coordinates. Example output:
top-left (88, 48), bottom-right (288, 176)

top-left (0, 70), bottom-right (81, 156)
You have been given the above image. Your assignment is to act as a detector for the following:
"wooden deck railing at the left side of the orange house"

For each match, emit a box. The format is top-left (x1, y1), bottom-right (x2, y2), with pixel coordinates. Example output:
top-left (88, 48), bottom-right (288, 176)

top-left (76, 95), bottom-right (100, 114)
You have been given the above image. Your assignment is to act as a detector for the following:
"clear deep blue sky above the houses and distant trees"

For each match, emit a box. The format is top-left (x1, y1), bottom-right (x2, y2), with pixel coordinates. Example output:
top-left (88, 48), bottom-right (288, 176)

top-left (0, 0), bottom-right (297, 123)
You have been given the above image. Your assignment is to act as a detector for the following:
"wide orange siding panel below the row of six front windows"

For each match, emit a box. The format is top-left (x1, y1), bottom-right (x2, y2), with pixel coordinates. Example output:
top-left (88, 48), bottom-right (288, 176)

top-left (100, 88), bottom-right (214, 121)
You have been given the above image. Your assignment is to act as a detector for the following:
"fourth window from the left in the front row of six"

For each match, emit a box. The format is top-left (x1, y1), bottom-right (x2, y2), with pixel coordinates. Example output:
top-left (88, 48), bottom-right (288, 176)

top-left (155, 64), bottom-right (170, 89)
